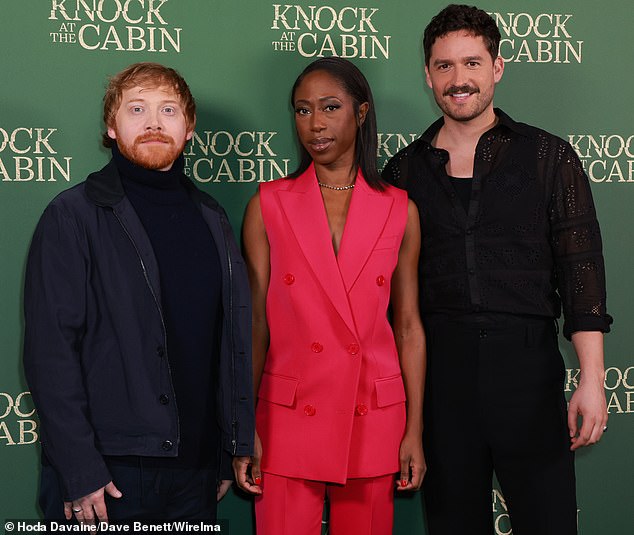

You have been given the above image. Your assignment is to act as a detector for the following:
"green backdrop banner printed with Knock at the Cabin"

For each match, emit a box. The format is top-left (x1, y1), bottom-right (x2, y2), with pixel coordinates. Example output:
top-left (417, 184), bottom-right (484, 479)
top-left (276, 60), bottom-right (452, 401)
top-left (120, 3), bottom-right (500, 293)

top-left (0, 0), bottom-right (634, 535)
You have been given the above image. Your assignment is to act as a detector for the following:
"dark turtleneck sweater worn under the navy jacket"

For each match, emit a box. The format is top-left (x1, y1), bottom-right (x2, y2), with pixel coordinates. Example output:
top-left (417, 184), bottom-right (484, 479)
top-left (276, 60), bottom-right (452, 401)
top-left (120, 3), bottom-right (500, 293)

top-left (112, 145), bottom-right (222, 467)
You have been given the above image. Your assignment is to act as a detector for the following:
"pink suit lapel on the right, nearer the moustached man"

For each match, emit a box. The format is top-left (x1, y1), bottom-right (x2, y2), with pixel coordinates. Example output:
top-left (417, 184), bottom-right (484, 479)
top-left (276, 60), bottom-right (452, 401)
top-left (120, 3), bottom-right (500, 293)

top-left (337, 172), bottom-right (394, 292)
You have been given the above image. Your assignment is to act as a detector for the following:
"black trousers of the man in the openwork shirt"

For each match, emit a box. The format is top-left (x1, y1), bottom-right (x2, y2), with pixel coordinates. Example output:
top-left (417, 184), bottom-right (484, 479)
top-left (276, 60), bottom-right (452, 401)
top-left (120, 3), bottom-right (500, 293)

top-left (423, 318), bottom-right (577, 535)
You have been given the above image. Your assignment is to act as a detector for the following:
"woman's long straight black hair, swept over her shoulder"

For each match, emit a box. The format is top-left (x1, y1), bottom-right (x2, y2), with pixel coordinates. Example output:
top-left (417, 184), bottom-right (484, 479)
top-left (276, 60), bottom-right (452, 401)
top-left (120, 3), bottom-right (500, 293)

top-left (288, 56), bottom-right (385, 191)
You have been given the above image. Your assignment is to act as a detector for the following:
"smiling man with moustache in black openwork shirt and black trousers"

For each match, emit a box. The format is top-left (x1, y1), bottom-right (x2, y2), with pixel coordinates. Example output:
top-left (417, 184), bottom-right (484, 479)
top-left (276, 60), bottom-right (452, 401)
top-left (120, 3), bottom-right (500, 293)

top-left (384, 5), bottom-right (612, 535)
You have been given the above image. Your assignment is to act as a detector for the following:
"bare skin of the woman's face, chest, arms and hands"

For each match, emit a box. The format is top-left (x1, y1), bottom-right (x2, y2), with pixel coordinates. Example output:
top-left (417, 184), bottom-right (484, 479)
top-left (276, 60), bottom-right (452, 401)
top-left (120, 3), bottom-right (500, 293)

top-left (234, 71), bottom-right (426, 494)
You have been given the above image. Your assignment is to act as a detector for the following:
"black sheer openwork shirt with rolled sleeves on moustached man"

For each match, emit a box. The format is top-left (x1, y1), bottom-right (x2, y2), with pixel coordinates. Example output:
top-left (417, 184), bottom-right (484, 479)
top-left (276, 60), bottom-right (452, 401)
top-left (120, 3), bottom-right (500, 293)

top-left (383, 109), bottom-right (612, 338)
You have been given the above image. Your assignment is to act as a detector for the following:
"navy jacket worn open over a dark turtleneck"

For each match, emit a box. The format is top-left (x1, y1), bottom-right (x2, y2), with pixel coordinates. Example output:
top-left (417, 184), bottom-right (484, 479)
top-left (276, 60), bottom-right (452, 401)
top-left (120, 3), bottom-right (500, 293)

top-left (24, 161), bottom-right (254, 500)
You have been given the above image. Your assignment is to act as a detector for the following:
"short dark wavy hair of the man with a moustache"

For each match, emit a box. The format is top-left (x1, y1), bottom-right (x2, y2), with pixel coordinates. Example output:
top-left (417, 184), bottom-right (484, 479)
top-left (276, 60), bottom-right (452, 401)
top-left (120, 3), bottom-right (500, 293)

top-left (423, 4), bottom-right (501, 67)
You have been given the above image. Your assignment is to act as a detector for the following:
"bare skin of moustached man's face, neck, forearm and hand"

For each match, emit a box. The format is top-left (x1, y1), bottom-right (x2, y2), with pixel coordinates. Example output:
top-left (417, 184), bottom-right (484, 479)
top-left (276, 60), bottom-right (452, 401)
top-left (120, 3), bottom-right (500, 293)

top-left (425, 31), bottom-right (608, 450)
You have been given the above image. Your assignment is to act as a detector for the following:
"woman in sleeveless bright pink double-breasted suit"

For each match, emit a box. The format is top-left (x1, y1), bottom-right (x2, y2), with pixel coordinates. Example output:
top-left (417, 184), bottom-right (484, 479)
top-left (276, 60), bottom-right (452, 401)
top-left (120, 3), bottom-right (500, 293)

top-left (234, 57), bottom-right (425, 535)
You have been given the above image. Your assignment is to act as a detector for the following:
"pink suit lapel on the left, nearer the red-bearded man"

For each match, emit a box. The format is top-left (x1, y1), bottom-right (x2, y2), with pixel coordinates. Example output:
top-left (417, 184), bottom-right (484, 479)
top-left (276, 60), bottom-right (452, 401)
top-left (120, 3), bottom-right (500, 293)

top-left (277, 165), bottom-right (356, 333)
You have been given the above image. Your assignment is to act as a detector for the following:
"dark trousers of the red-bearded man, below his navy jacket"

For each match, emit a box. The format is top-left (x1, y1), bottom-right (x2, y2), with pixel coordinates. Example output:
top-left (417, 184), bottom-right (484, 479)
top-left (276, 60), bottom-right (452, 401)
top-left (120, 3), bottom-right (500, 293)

top-left (40, 457), bottom-right (217, 521)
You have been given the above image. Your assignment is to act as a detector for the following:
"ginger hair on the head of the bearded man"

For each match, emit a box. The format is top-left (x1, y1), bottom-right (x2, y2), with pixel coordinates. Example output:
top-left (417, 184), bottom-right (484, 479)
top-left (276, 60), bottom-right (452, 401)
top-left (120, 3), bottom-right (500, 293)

top-left (102, 62), bottom-right (196, 147)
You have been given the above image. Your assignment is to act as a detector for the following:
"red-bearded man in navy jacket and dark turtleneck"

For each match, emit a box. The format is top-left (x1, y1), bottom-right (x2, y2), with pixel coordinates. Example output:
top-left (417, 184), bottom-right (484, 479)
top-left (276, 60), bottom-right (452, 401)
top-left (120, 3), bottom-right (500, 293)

top-left (24, 63), bottom-right (254, 523)
